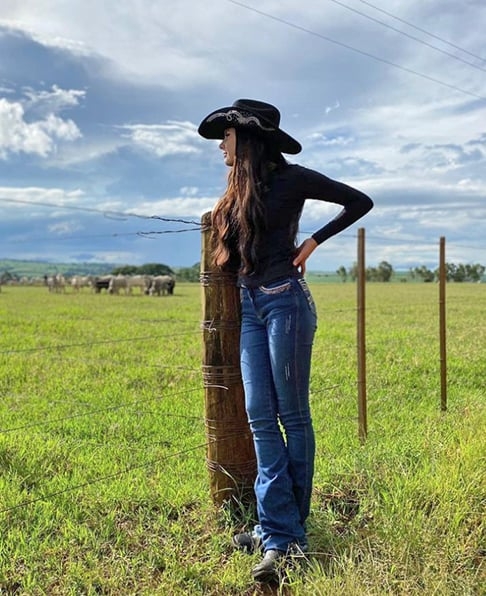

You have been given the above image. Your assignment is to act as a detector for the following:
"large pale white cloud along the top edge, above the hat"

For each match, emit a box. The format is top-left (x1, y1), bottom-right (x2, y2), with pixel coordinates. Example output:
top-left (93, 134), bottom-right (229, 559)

top-left (0, 0), bottom-right (406, 88)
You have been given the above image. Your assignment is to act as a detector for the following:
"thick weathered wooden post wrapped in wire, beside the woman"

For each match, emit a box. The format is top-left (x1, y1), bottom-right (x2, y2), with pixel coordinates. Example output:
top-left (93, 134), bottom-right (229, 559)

top-left (201, 213), bottom-right (256, 506)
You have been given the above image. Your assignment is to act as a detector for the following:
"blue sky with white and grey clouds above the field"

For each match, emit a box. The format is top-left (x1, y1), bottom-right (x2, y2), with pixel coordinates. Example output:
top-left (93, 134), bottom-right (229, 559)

top-left (0, 0), bottom-right (486, 271)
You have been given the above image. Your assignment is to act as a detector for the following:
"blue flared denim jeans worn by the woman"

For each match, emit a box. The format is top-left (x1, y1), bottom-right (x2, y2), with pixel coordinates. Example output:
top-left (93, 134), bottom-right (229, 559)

top-left (240, 277), bottom-right (317, 551)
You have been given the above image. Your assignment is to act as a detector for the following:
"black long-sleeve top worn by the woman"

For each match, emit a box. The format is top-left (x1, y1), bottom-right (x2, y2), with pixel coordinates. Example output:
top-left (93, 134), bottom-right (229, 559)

top-left (238, 164), bottom-right (373, 288)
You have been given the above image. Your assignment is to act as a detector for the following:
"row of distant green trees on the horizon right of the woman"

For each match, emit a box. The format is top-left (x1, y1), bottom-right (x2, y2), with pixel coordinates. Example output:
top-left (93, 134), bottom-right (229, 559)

top-left (336, 261), bottom-right (486, 282)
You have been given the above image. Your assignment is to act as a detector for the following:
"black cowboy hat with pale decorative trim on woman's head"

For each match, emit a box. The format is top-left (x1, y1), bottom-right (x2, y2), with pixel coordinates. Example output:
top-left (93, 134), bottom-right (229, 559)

top-left (198, 99), bottom-right (302, 155)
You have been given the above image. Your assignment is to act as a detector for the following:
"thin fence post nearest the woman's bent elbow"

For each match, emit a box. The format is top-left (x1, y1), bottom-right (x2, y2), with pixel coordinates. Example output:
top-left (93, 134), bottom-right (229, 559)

top-left (357, 228), bottom-right (368, 443)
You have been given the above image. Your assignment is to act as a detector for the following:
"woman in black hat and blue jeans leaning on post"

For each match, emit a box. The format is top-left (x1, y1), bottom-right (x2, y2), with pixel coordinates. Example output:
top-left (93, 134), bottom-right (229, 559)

top-left (198, 99), bottom-right (373, 581)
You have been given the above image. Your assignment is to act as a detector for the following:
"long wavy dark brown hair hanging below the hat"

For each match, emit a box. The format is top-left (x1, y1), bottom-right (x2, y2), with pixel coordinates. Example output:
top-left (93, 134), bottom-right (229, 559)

top-left (211, 130), bottom-right (287, 274)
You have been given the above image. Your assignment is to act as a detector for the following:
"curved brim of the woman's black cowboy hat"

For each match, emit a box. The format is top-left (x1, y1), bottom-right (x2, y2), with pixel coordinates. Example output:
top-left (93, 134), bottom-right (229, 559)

top-left (197, 106), bottom-right (302, 155)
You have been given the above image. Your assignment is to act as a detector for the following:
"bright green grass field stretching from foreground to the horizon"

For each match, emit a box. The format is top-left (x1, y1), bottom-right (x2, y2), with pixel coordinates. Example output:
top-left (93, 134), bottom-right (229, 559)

top-left (0, 283), bottom-right (486, 596)
